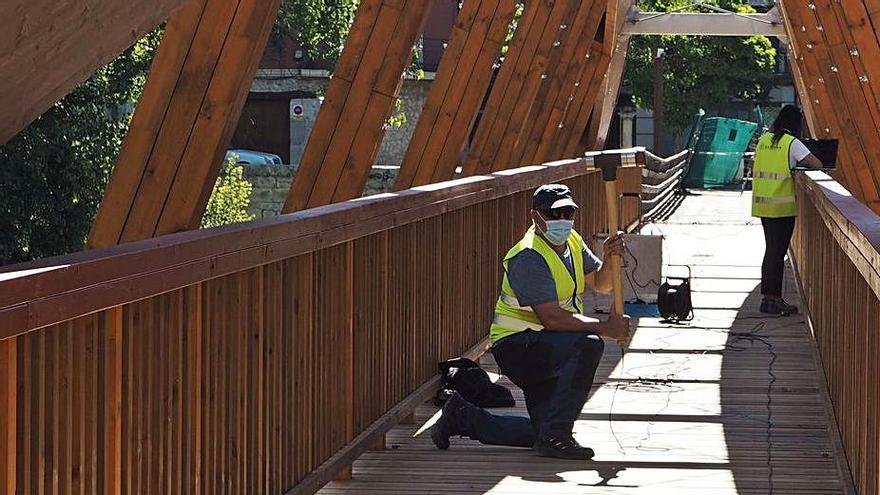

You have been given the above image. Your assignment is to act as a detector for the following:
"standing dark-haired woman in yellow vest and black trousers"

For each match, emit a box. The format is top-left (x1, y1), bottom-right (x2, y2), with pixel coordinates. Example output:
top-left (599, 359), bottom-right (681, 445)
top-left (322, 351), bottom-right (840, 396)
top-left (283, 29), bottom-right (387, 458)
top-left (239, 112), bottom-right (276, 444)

top-left (752, 105), bottom-right (822, 315)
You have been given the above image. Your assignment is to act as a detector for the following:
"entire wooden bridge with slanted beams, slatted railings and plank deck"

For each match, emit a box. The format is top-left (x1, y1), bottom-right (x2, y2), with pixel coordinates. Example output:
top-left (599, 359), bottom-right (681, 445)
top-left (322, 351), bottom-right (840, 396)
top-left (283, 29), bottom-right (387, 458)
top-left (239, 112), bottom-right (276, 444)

top-left (0, 0), bottom-right (880, 495)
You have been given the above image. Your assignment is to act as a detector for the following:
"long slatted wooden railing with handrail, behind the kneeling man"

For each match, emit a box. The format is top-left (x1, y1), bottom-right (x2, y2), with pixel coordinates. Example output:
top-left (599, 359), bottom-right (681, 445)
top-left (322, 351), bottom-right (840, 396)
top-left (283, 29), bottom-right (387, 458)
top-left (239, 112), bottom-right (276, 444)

top-left (0, 154), bottom-right (641, 494)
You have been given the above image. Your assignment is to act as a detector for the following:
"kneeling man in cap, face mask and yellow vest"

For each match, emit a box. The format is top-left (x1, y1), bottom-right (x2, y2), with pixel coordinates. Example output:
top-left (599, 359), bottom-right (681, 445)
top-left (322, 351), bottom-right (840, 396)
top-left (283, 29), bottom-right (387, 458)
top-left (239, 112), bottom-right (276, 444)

top-left (431, 184), bottom-right (629, 459)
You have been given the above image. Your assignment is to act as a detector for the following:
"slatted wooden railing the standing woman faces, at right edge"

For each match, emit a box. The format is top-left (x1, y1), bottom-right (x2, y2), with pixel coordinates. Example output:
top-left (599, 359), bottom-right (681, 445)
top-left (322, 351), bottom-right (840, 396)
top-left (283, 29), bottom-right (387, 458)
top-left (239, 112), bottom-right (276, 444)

top-left (792, 172), bottom-right (880, 495)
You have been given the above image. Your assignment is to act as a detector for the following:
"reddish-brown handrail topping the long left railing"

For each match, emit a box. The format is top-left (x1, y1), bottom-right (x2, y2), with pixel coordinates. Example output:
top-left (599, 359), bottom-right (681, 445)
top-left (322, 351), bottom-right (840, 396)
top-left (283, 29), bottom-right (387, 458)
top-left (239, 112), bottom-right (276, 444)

top-left (0, 153), bottom-right (640, 340)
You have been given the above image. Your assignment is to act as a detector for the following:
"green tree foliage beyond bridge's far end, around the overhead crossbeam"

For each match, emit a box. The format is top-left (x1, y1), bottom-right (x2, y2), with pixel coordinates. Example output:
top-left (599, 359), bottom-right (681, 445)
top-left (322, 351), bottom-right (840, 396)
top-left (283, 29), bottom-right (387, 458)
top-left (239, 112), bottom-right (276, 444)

top-left (625, 0), bottom-right (776, 130)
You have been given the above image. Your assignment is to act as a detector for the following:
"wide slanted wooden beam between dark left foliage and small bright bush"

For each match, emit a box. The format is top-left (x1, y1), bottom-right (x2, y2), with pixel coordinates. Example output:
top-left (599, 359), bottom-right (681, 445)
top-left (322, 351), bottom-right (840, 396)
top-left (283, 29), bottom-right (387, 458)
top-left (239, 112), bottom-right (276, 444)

top-left (89, 0), bottom-right (280, 247)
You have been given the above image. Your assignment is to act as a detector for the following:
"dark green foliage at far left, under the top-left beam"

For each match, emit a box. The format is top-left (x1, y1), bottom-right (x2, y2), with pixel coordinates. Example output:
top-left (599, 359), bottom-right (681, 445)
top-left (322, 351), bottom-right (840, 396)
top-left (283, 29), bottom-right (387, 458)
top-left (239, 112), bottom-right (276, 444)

top-left (0, 30), bottom-right (160, 264)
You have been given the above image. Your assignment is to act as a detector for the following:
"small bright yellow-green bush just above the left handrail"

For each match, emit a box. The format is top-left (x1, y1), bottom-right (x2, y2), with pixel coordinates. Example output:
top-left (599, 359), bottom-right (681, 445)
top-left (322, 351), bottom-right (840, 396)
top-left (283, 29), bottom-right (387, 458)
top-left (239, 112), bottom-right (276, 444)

top-left (202, 155), bottom-right (254, 228)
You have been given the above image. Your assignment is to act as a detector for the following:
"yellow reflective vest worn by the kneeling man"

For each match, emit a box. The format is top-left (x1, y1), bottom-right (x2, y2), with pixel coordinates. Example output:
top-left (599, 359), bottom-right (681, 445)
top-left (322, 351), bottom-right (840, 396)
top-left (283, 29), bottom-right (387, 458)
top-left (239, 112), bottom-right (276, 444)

top-left (489, 225), bottom-right (585, 343)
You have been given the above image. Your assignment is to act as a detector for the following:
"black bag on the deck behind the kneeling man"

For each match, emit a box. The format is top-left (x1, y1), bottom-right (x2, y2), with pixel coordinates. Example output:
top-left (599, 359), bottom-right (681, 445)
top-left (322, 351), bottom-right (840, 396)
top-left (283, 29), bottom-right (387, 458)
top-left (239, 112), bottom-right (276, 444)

top-left (434, 357), bottom-right (516, 407)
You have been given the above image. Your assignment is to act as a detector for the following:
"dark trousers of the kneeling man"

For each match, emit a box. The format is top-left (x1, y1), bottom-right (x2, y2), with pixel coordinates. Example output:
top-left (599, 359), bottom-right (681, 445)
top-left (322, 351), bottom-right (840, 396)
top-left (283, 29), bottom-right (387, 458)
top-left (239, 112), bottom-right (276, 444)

top-left (454, 330), bottom-right (605, 447)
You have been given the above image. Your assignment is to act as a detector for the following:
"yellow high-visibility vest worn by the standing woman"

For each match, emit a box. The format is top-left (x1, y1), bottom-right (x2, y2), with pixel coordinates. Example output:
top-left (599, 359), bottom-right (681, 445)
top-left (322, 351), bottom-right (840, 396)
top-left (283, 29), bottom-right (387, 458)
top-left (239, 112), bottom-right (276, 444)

top-left (752, 132), bottom-right (797, 218)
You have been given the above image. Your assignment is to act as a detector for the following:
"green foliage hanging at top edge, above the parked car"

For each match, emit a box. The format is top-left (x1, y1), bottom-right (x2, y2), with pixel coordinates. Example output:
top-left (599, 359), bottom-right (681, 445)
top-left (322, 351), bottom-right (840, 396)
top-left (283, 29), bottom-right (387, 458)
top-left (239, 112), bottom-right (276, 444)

top-left (272, 0), bottom-right (358, 62)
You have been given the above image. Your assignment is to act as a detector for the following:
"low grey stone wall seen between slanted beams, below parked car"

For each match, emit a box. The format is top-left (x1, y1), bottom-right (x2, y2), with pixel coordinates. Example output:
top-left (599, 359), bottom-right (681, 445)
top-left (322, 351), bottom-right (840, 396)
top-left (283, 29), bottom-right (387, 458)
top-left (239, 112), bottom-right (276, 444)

top-left (244, 165), bottom-right (398, 218)
